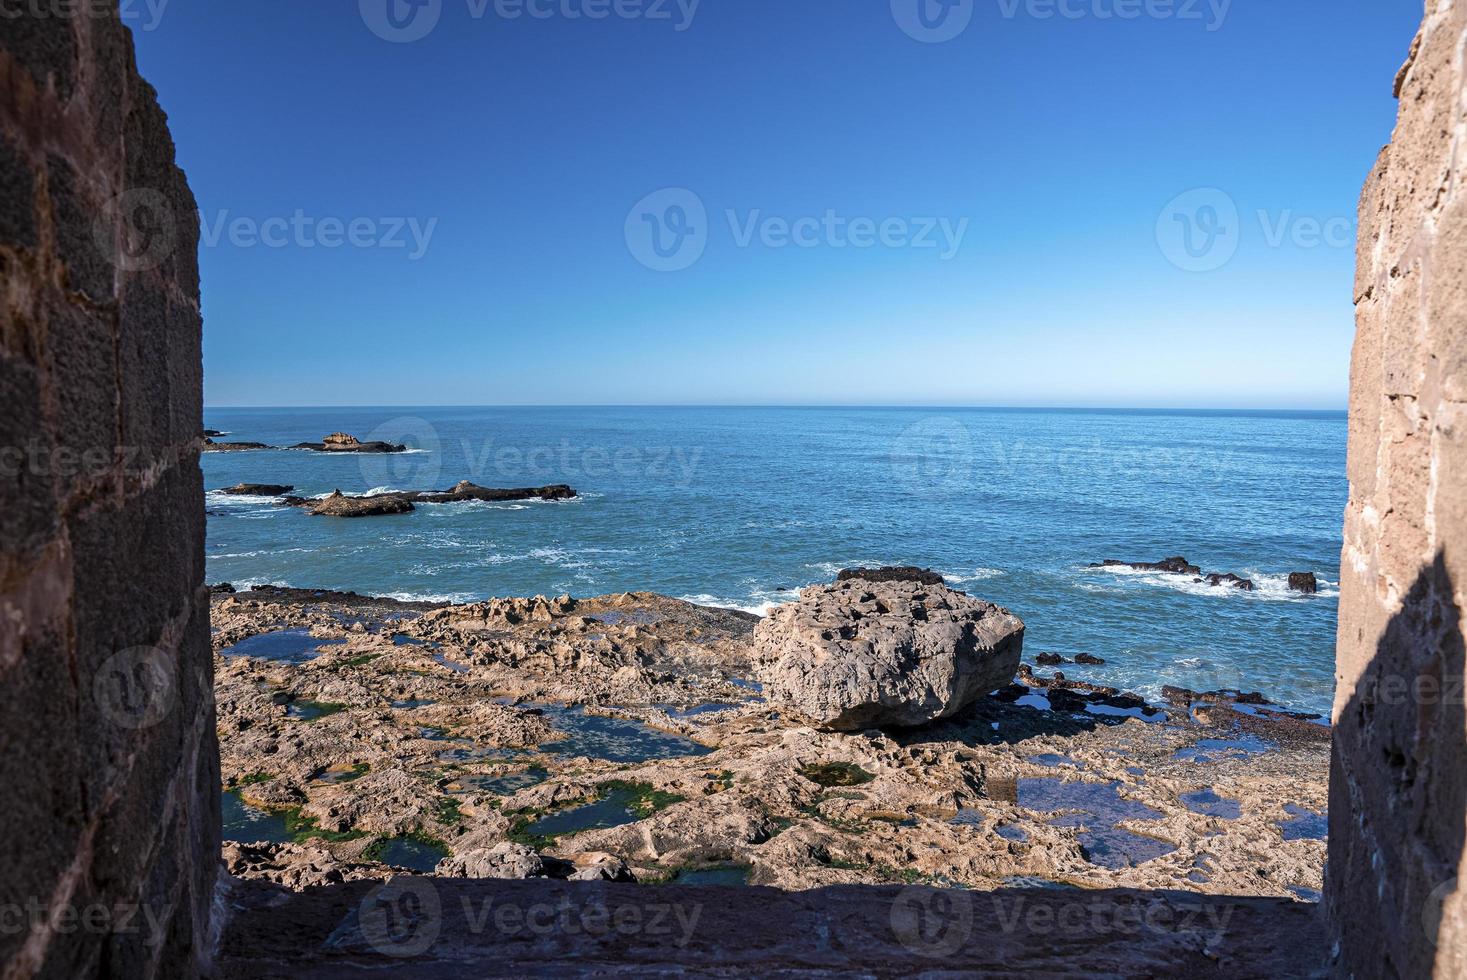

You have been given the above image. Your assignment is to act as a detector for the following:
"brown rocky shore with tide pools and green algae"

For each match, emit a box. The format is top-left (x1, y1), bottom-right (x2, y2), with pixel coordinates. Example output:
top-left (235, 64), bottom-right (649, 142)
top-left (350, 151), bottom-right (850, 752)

top-left (213, 575), bottom-right (1329, 901)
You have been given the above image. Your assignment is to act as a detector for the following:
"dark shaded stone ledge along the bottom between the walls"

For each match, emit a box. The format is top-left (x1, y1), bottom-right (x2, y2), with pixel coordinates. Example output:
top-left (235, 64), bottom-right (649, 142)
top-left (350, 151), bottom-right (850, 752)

top-left (216, 876), bottom-right (1328, 980)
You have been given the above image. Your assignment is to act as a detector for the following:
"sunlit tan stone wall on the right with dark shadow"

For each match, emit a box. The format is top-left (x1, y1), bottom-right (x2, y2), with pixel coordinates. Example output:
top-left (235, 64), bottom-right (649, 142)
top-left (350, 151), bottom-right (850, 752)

top-left (1326, 0), bottom-right (1467, 977)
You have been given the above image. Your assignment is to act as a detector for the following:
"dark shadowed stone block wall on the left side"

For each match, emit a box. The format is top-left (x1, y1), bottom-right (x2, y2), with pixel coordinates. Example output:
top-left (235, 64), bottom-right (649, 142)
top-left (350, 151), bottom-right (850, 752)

top-left (0, 3), bottom-right (219, 980)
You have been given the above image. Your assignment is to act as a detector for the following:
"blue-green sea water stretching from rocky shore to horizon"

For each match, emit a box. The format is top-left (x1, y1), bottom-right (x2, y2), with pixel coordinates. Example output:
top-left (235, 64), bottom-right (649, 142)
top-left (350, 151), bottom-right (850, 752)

top-left (202, 408), bottom-right (1347, 712)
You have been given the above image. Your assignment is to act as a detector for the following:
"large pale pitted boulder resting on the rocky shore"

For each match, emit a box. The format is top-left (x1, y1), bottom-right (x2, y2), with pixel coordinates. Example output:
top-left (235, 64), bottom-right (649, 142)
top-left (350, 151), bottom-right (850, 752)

top-left (754, 578), bottom-right (1024, 731)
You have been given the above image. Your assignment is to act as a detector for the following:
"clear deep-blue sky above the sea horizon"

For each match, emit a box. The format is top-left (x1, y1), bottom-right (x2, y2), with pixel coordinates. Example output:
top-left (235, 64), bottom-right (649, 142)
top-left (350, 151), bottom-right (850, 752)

top-left (134, 0), bottom-right (1422, 408)
